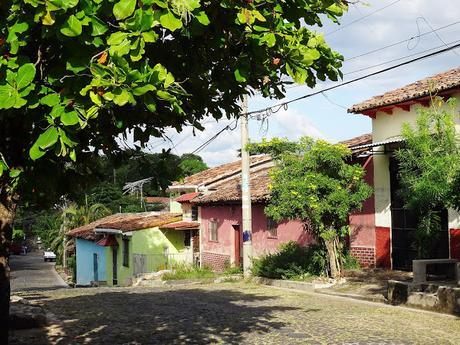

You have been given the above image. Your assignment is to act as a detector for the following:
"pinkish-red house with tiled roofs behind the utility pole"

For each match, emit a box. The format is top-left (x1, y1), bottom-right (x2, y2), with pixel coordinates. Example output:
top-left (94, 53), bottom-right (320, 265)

top-left (169, 135), bottom-right (372, 270)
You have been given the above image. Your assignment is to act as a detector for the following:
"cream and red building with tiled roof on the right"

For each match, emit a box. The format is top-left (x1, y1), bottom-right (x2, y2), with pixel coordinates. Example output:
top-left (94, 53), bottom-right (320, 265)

top-left (348, 68), bottom-right (460, 270)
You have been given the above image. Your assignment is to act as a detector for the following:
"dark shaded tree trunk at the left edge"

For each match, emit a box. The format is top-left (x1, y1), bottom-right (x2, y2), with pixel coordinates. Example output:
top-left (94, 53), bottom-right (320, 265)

top-left (0, 195), bottom-right (16, 344)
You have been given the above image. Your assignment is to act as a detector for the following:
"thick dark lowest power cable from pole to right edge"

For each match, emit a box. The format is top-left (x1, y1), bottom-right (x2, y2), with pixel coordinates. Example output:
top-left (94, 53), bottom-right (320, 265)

top-left (246, 44), bottom-right (460, 115)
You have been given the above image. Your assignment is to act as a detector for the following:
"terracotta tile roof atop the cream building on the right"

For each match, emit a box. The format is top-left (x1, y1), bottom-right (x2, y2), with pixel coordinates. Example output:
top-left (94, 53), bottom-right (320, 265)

top-left (348, 67), bottom-right (460, 114)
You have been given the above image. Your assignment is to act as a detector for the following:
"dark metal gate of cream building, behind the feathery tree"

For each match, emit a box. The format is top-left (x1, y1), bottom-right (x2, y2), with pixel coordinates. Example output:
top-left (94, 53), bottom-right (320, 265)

top-left (390, 158), bottom-right (449, 271)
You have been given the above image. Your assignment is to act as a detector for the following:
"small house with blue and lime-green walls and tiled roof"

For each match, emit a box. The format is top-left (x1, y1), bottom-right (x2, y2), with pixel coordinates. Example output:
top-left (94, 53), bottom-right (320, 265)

top-left (67, 212), bottom-right (193, 286)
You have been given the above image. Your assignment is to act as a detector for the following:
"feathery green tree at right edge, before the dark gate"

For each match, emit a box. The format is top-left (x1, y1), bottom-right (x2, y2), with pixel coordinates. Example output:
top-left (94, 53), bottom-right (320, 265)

top-left (395, 98), bottom-right (460, 258)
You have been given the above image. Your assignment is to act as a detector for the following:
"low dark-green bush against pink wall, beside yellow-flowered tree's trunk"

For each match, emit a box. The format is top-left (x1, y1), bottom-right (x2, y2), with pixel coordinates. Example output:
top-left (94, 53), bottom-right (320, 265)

top-left (252, 241), bottom-right (327, 280)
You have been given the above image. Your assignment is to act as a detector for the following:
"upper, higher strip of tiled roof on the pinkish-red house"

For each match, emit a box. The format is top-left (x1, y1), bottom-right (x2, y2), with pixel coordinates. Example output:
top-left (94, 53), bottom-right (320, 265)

top-left (172, 155), bottom-right (272, 187)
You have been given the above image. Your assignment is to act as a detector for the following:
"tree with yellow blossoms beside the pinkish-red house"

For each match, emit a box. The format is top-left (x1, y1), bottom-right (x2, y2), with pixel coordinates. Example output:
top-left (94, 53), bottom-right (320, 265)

top-left (250, 137), bottom-right (372, 277)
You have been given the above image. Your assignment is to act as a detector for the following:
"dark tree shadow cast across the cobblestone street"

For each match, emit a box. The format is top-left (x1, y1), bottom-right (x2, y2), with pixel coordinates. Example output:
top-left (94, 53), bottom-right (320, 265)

top-left (10, 288), bottom-right (308, 344)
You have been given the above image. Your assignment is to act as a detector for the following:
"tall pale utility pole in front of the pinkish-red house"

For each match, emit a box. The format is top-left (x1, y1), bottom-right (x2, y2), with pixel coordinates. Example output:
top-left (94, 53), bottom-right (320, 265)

top-left (241, 95), bottom-right (252, 276)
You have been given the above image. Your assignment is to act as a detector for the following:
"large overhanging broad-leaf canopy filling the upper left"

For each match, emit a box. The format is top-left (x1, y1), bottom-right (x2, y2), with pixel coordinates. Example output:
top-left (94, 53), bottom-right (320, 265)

top-left (0, 0), bottom-right (347, 198)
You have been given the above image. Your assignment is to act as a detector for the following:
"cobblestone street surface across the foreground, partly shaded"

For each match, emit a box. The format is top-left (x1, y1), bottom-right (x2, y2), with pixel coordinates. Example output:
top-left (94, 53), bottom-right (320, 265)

top-left (12, 283), bottom-right (460, 345)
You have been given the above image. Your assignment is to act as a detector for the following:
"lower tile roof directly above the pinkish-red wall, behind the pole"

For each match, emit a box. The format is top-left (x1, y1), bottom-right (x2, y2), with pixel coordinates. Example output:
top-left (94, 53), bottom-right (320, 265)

top-left (193, 167), bottom-right (271, 204)
